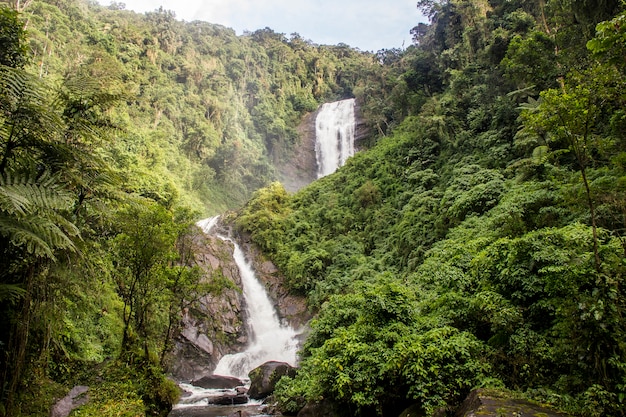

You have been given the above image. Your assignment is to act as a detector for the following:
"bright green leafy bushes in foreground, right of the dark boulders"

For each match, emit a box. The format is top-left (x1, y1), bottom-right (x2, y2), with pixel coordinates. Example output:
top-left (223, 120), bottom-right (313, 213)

top-left (276, 277), bottom-right (486, 415)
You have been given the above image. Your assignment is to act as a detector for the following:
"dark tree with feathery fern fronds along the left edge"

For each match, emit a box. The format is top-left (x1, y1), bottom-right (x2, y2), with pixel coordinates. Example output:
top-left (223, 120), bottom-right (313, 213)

top-left (0, 7), bottom-right (79, 410)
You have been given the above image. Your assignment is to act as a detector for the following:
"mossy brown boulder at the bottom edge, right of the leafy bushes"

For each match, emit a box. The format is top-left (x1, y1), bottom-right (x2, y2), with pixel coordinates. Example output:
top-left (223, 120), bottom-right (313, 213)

top-left (454, 389), bottom-right (571, 417)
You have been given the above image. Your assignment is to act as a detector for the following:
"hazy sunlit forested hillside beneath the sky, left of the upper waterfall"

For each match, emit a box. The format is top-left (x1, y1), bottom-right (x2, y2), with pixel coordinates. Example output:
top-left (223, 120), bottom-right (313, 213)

top-left (12, 0), bottom-right (388, 214)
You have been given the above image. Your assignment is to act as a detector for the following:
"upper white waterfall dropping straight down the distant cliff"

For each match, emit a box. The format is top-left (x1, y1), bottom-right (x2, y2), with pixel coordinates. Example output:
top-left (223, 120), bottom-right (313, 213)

top-left (315, 98), bottom-right (355, 178)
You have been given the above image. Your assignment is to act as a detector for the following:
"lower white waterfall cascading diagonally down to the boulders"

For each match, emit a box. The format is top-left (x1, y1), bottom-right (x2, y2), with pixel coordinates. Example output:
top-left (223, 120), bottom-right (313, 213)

top-left (198, 218), bottom-right (298, 378)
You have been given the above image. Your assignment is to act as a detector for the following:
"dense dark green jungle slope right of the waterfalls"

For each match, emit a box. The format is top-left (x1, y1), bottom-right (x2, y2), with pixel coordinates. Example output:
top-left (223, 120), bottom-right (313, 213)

top-left (236, 0), bottom-right (626, 416)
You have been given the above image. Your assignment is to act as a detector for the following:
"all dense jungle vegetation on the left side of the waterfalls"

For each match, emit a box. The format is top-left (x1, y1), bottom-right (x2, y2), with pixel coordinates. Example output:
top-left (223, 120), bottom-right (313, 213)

top-left (0, 0), bottom-right (394, 416)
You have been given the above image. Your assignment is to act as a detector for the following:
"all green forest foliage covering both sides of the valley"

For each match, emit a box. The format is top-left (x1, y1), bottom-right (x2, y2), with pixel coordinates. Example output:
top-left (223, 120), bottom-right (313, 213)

top-left (0, 0), bottom-right (626, 416)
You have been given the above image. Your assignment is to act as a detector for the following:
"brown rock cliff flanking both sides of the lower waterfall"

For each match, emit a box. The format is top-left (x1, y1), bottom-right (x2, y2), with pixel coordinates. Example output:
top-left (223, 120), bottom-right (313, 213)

top-left (169, 221), bottom-right (311, 381)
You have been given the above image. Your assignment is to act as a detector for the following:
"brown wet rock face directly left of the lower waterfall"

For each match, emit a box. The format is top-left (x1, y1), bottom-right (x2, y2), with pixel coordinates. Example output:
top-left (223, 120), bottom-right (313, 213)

top-left (169, 231), bottom-right (248, 381)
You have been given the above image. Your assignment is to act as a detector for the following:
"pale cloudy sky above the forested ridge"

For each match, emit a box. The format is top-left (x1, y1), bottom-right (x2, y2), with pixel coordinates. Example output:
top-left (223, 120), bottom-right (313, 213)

top-left (98, 0), bottom-right (426, 52)
